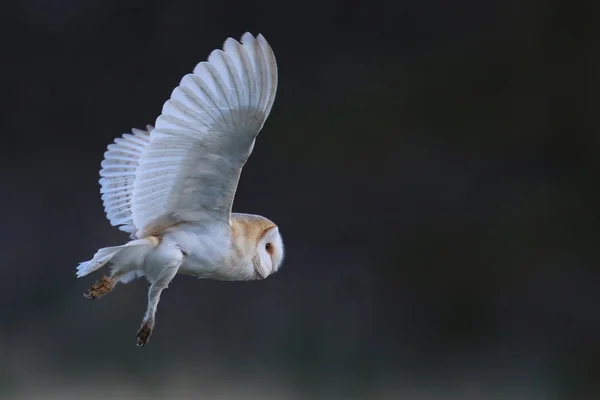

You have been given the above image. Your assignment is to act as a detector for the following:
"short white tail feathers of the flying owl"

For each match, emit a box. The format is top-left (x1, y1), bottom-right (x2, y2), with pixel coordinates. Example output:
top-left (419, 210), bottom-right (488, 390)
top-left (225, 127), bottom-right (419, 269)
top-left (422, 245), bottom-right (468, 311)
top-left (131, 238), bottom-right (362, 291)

top-left (77, 237), bottom-right (159, 278)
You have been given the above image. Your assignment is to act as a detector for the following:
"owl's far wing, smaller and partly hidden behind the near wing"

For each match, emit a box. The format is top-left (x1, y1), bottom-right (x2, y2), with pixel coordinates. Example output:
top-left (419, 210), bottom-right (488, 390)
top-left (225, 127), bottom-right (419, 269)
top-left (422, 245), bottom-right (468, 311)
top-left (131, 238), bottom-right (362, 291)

top-left (100, 125), bottom-right (154, 235)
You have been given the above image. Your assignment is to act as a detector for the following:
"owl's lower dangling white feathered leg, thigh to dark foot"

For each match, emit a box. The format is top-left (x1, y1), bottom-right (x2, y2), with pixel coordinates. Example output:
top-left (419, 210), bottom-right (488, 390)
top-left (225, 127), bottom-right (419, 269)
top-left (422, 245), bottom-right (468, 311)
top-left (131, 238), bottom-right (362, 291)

top-left (137, 243), bottom-right (183, 347)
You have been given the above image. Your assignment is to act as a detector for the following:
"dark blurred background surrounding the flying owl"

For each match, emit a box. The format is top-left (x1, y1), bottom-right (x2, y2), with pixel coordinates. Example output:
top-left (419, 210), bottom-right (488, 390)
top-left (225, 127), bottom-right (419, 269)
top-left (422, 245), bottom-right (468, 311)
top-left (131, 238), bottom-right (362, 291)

top-left (0, 0), bottom-right (600, 400)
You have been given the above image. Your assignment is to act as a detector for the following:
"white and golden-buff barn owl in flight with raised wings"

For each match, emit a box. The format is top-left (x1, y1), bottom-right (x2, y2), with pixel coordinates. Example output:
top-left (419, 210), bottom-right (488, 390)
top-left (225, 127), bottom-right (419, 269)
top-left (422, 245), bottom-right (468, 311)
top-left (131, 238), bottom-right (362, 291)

top-left (77, 33), bottom-right (284, 347)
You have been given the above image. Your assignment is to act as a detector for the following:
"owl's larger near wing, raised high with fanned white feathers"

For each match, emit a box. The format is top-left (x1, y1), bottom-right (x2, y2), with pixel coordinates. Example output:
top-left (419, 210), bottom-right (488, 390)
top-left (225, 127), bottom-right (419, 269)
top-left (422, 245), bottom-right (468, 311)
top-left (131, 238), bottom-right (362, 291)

top-left (131, 33), bottom-right (277, 237)
